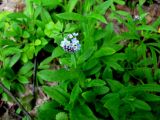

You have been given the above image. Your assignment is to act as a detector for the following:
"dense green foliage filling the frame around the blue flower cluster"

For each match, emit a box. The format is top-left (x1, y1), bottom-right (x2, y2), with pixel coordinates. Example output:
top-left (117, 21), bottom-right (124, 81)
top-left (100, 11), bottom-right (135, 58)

top-left (0, 0), bottom-right (160, 120)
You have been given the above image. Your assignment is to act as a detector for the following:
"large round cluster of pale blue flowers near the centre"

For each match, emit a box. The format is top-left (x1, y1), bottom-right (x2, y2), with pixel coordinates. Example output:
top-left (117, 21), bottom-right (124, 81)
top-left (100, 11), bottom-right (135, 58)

top-left (60, 33), bottom-right (81, 53)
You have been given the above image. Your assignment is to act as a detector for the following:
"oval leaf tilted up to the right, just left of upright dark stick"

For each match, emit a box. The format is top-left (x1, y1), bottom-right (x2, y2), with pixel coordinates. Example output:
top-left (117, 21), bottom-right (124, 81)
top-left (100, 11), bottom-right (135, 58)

top-left (18, 62), bottom-right (33, 75)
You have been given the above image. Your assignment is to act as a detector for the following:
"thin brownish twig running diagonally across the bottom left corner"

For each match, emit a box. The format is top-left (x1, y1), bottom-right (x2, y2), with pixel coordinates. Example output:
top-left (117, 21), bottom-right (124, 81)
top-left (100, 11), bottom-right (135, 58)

top-left (0, 82), bottom-right (32, 120)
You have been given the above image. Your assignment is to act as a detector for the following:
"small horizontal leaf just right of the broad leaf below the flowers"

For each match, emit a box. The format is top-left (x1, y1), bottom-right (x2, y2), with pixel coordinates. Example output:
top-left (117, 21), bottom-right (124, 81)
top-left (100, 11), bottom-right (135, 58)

top-left (87, 79), bottom-right (106, 87)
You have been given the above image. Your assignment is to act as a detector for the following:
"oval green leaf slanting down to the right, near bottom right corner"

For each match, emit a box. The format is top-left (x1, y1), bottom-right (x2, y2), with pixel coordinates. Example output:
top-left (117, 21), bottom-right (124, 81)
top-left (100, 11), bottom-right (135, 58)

top-left (132, 99), bottom-right (151, 111)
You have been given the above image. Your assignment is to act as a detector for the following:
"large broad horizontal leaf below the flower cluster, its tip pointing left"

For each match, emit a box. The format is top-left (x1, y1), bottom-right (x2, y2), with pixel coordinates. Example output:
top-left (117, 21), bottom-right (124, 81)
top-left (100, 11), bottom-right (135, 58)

top-left (38, 69), bottom-right (78, 82)
